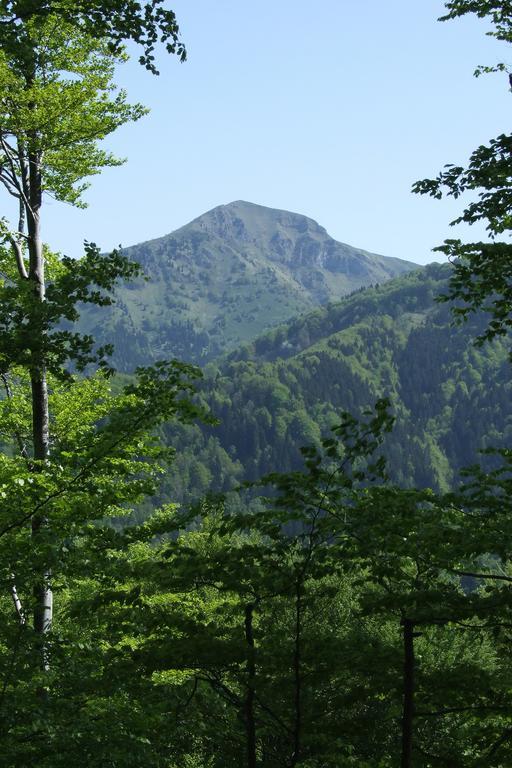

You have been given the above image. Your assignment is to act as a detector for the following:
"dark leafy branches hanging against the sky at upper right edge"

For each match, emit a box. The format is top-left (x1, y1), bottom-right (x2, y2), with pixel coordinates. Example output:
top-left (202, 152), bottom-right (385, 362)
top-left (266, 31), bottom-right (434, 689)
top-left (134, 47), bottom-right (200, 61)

top-left (413, 0), bottom-right (512, 352)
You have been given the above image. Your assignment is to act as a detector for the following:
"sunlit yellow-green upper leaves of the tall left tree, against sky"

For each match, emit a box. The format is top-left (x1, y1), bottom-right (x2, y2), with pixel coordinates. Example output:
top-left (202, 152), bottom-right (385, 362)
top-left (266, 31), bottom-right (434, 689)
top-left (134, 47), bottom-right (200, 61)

top-left (0, 17), bottom-right (146, 205)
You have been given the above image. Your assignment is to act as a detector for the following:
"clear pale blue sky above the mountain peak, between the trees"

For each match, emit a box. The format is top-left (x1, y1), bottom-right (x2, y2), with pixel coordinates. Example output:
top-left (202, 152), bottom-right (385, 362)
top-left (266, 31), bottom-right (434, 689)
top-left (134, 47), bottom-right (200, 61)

top-left (44, 0), bottom-right (512, 263)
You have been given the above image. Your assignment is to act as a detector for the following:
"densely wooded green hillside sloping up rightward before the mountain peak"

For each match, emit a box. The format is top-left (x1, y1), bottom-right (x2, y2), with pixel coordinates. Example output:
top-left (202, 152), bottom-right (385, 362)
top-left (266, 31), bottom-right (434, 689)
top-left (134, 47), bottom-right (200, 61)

top-left (155, 264), bottom-right (512, 508)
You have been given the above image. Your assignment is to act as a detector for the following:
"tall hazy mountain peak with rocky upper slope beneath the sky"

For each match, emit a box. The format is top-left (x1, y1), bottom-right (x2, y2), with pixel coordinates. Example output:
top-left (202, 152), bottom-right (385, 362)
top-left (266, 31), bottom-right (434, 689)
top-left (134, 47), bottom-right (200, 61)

top-left (82, 201), bottom-right (418, 370)
